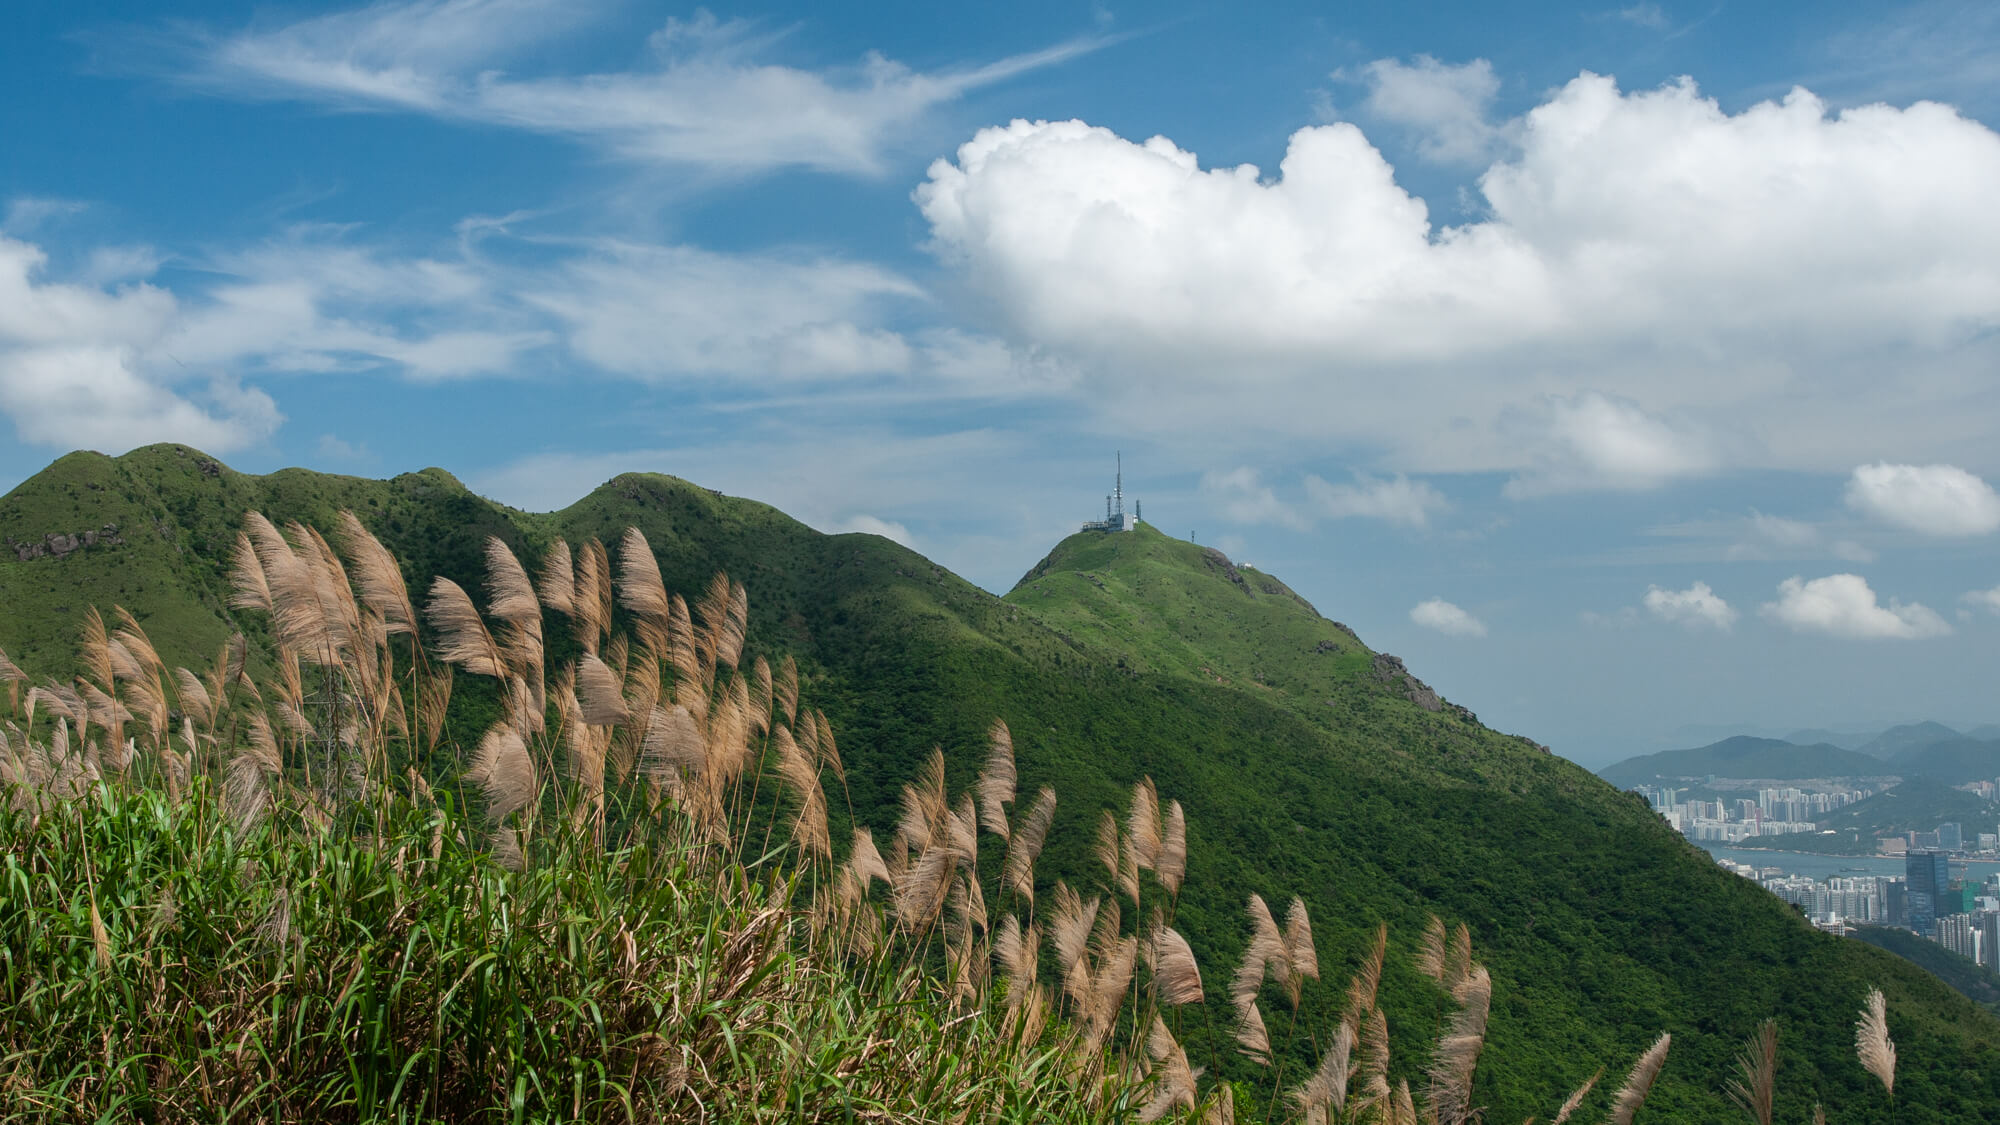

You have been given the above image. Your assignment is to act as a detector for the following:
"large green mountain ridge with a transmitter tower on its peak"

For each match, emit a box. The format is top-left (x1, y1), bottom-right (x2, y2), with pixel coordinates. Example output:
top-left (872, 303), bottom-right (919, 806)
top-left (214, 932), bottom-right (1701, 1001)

top-left (0, 446), bottom-right (2000, 1125)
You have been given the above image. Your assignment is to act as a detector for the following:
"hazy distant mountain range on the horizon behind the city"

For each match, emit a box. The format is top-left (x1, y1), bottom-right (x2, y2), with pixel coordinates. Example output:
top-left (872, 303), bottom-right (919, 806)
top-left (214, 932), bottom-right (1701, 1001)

top-left (1598, 723), bottom-right (2000, 789)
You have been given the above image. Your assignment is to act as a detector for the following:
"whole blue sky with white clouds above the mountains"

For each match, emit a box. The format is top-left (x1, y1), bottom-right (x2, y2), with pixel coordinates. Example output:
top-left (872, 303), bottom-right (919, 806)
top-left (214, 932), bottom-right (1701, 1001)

top-left (0, 0), bottom-right (2000, 765)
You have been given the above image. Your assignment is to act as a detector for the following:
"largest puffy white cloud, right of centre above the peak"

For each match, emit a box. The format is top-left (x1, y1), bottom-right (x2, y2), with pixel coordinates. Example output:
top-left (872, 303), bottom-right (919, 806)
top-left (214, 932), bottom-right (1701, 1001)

top-left (916, 74), bottom-right (2000, 476)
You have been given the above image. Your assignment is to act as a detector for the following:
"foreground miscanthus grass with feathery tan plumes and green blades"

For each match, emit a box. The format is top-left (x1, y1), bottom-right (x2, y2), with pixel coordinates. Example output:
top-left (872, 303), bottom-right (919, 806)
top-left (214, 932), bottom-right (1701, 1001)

top-left (0, 512), bottom-right (1894, 1125)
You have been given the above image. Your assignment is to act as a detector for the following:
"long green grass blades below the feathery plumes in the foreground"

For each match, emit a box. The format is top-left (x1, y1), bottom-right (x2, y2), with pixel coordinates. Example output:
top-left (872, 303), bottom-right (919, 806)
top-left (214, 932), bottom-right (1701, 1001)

top-left (0, 787), bottom-right (1120, 1121)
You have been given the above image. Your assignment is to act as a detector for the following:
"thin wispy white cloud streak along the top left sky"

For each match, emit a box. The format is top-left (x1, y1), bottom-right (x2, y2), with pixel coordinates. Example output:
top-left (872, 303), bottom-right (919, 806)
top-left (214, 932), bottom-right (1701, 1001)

top-left (192, 0), bottom-right (1098, 174)
